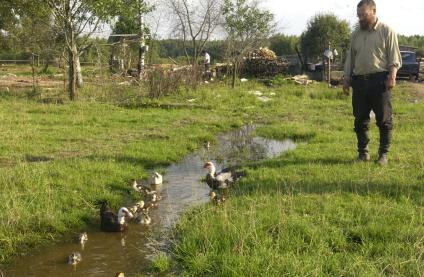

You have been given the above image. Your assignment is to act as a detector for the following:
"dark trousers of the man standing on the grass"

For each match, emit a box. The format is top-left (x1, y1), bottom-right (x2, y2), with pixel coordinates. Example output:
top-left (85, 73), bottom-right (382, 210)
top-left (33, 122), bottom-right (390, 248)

top-left (352, 72), bottom-right (393, 155)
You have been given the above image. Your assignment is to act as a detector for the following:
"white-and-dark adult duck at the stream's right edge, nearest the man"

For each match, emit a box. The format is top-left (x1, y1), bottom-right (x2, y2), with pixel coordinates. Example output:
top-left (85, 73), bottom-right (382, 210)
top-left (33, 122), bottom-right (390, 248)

top-left (203, 162), bottom-right (246, 189)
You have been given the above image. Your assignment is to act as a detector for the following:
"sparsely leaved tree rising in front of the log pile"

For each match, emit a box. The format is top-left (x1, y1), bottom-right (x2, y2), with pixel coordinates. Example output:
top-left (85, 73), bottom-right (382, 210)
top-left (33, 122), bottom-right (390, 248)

top-left (223, 0), bottom-right (274, 87)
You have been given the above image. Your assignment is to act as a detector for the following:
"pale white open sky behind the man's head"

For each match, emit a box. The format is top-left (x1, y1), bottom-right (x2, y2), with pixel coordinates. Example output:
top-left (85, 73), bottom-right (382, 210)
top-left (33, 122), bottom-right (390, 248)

top-left (262, 0), bottom-right (424, 36)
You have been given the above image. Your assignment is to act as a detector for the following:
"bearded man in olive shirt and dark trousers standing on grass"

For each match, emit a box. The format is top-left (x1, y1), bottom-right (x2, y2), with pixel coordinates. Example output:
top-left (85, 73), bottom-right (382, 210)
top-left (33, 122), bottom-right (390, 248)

top-left (343, 0), bottom-right (402, 165)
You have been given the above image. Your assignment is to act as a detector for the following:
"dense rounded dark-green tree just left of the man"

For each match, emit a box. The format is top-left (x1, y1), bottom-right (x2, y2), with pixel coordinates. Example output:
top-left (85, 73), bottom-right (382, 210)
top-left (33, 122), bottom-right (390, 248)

top-left (300, 14), bottom-right (350, 63)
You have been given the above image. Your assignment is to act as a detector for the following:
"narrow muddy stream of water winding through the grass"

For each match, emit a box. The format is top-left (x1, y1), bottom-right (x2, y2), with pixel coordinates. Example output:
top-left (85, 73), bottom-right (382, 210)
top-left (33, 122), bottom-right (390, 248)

top-left (4, 127), bottom-right (296, 277)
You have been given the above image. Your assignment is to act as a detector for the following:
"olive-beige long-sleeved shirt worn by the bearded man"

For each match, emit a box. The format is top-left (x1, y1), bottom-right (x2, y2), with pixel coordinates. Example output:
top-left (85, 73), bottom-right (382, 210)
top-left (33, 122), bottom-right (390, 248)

top-left (344, 19), bottom-right (402, 80)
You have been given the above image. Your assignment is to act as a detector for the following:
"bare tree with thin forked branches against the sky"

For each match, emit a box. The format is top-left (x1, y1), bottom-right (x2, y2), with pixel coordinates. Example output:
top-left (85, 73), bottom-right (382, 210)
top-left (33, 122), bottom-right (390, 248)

top-left (168, 0), bottom-right (222, 66)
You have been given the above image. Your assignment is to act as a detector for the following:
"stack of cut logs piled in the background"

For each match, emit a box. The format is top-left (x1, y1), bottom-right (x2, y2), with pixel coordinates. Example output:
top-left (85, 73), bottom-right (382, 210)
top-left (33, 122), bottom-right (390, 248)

top-left (242, 48), bottom-right (289, 77)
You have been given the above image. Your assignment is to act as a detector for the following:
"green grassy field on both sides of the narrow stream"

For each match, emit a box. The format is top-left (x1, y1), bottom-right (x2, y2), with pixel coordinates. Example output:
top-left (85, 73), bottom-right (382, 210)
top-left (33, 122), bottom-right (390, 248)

top-left (0, 74), bottom-right (424, 276)
